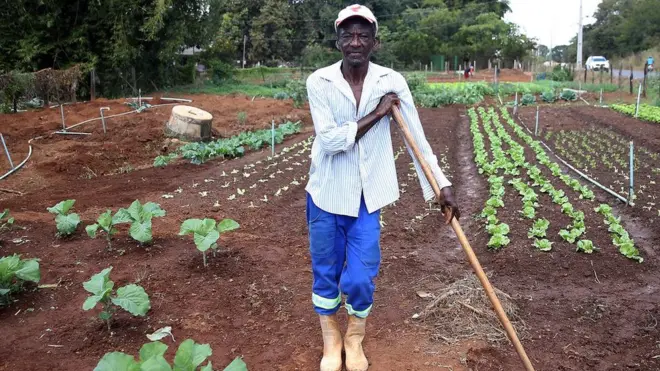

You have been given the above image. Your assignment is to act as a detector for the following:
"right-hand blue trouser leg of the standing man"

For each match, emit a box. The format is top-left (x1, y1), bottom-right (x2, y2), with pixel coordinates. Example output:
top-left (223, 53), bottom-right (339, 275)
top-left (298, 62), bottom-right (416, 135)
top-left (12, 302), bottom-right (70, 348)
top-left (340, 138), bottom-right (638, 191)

top-left (339, 196), bottom-right (380, 318)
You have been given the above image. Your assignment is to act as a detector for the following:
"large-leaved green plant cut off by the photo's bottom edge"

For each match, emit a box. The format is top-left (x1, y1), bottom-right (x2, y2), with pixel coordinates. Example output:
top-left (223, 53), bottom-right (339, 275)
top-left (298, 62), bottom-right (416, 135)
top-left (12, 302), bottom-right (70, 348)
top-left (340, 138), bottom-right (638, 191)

top-left (94, 339), bottom-right (247, 371)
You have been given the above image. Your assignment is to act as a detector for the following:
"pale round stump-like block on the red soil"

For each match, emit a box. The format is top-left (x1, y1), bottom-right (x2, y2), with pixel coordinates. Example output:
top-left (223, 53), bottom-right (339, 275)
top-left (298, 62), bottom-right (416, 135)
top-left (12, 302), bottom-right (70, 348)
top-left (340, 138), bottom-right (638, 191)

top-left (165, 106), bottom-right (213, 141)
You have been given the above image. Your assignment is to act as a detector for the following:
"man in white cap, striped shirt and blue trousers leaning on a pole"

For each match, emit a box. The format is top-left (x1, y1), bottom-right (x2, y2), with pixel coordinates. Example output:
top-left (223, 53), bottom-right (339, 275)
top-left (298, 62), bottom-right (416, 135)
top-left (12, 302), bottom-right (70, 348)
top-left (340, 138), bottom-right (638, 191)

top-left (306, 5), bottom-right (460, 371)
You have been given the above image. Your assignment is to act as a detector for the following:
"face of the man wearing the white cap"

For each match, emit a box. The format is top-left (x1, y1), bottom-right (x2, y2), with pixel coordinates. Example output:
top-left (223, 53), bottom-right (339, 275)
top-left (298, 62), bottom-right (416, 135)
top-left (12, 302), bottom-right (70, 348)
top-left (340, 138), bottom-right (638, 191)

top-left (337, 17), bottom-right (378, 67)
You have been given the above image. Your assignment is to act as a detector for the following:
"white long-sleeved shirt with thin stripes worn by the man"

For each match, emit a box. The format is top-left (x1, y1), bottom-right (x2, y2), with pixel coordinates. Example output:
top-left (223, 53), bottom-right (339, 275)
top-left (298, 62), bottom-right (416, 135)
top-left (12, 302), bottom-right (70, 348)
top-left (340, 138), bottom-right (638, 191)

top-left (305, 61), bottom-right (451, 217)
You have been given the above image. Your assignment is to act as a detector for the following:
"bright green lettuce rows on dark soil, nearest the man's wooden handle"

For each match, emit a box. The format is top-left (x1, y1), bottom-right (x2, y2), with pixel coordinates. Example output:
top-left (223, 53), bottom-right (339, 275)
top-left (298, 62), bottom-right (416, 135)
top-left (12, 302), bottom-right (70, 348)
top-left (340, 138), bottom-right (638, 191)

top-left (468, 107), bottom-right (643, 262)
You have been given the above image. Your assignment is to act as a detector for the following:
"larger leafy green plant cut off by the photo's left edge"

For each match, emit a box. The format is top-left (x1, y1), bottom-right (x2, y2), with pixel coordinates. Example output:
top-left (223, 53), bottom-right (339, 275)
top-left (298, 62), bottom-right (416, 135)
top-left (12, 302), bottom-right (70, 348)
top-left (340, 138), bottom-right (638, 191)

top-left (0, 254), bottom-right (41, 307)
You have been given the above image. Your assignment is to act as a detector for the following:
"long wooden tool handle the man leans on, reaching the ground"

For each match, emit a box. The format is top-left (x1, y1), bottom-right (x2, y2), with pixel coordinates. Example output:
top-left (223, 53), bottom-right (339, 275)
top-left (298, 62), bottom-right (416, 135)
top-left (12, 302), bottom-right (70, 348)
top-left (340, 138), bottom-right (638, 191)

top-left (392, 106), bottom-right (534, 371)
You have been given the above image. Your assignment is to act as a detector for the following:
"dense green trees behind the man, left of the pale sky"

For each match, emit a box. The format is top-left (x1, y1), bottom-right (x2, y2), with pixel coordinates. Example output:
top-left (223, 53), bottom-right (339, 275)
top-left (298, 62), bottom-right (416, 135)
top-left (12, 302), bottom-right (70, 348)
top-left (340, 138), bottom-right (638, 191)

top-left (0, 0), bottom-right (534, 97)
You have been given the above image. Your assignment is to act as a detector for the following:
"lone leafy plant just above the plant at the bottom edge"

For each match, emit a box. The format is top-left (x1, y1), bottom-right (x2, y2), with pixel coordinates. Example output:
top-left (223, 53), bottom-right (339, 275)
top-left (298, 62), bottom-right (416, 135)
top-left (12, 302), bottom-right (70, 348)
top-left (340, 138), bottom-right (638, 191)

top-left (82, 267), bottom-right (151, 330)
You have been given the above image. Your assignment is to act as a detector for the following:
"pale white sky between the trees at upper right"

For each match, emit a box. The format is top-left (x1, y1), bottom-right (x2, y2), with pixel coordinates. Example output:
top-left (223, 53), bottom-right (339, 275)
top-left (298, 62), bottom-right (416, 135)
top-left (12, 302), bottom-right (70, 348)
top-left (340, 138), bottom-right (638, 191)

top-left (504, 0), bottom-right (602, 47)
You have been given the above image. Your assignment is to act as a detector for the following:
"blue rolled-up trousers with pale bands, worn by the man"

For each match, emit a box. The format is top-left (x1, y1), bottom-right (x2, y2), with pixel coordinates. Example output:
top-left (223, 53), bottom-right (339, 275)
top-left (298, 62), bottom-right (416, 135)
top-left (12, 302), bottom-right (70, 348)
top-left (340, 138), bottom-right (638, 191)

top-left (307, 194), bottom-right (380, 318)
